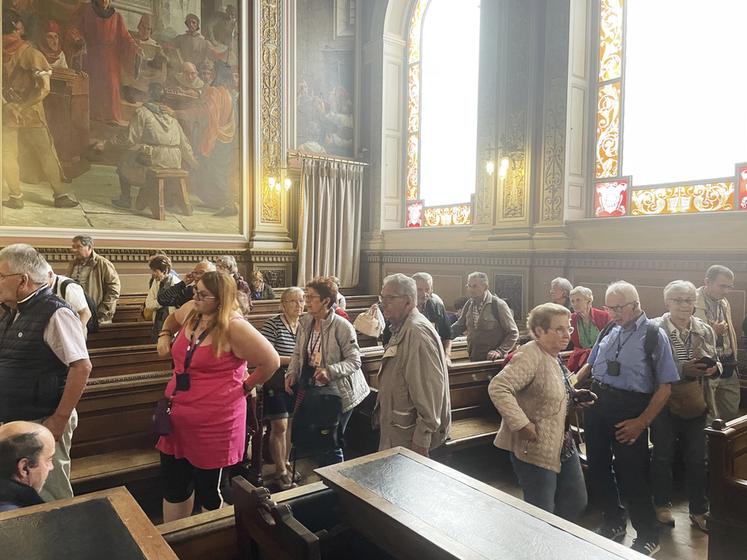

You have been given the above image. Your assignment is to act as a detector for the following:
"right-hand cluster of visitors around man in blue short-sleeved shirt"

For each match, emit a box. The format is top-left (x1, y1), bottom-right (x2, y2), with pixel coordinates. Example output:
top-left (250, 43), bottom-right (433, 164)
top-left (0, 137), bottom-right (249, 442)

top-left (489, 265), bottom-right (739, 556)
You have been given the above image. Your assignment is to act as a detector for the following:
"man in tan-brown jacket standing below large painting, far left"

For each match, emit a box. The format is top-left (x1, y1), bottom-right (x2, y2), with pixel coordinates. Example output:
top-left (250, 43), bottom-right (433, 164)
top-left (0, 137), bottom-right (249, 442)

top-left (66, 235), bottom-right (120, 323)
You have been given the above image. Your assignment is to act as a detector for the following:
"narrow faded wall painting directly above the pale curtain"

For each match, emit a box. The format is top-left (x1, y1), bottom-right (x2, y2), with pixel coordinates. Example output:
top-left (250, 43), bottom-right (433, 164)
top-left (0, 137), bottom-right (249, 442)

top-left (296, 0), bottom-right (356, 157)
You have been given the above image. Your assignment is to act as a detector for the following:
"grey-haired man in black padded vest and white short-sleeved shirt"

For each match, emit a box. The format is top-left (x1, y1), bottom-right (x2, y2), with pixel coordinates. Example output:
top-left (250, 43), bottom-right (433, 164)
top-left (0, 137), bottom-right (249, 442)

top-left (0, 243), bottom-right (91, 500)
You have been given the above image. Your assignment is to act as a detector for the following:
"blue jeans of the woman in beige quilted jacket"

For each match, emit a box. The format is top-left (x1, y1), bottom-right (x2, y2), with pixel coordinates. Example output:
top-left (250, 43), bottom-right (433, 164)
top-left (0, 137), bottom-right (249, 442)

top-left (511, 446), bottom-right (587, 521)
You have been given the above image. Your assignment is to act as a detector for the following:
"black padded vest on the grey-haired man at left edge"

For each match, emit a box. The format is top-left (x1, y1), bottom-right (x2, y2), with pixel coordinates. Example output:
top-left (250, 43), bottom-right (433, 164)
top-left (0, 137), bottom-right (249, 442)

top-left (0, 288), bottom-right (69, 422)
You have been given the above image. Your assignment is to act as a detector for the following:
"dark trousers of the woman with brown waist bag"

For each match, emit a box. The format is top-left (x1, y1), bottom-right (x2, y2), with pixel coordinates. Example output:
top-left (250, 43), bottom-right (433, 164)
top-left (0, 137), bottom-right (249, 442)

top-left (651, 406), bottom-right (708, 515)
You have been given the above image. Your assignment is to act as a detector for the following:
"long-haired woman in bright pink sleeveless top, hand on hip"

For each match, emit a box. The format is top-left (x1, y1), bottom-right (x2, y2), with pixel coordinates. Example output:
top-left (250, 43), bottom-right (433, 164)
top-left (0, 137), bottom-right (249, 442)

top-left (156, 272), bottom-right (280, 522)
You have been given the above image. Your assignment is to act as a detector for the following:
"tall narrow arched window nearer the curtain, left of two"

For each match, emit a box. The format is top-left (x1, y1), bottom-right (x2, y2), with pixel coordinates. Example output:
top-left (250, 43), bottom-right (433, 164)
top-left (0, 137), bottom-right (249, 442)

top-left (406, 0), bottom-right (480, 227)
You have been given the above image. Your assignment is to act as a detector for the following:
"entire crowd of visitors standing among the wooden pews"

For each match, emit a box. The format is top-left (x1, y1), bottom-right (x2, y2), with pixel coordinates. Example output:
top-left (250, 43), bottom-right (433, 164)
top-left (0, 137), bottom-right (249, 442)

top-left (0, 241), bottom-right (739, 555)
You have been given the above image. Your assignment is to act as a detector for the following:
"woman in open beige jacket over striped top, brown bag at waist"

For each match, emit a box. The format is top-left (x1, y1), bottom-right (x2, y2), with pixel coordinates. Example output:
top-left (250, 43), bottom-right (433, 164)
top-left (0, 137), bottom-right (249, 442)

top-left (651, 280), bottom-right (721, 531)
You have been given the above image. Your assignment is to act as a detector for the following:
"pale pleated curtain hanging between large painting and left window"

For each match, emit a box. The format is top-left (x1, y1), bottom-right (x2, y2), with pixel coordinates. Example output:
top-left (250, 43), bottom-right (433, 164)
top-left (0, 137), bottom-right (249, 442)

top-left (298, 158), bottom-right (363, 286)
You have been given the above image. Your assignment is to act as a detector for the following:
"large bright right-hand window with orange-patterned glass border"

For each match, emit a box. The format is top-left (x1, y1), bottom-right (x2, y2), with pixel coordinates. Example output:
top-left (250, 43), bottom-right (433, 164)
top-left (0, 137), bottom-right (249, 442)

top-left (594, 0), bottom-right (747, 216)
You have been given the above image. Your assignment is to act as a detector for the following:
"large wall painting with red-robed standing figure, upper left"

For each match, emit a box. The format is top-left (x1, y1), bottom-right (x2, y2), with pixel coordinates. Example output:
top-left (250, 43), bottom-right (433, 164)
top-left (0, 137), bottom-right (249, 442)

top-left (0, 0), bottom-right (241, 233)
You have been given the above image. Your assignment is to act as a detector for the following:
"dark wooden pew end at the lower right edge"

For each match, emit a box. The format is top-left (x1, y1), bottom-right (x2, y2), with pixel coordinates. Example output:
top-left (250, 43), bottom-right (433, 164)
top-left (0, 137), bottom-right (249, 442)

top-left (706, 416), bottom-right (747, 560)
